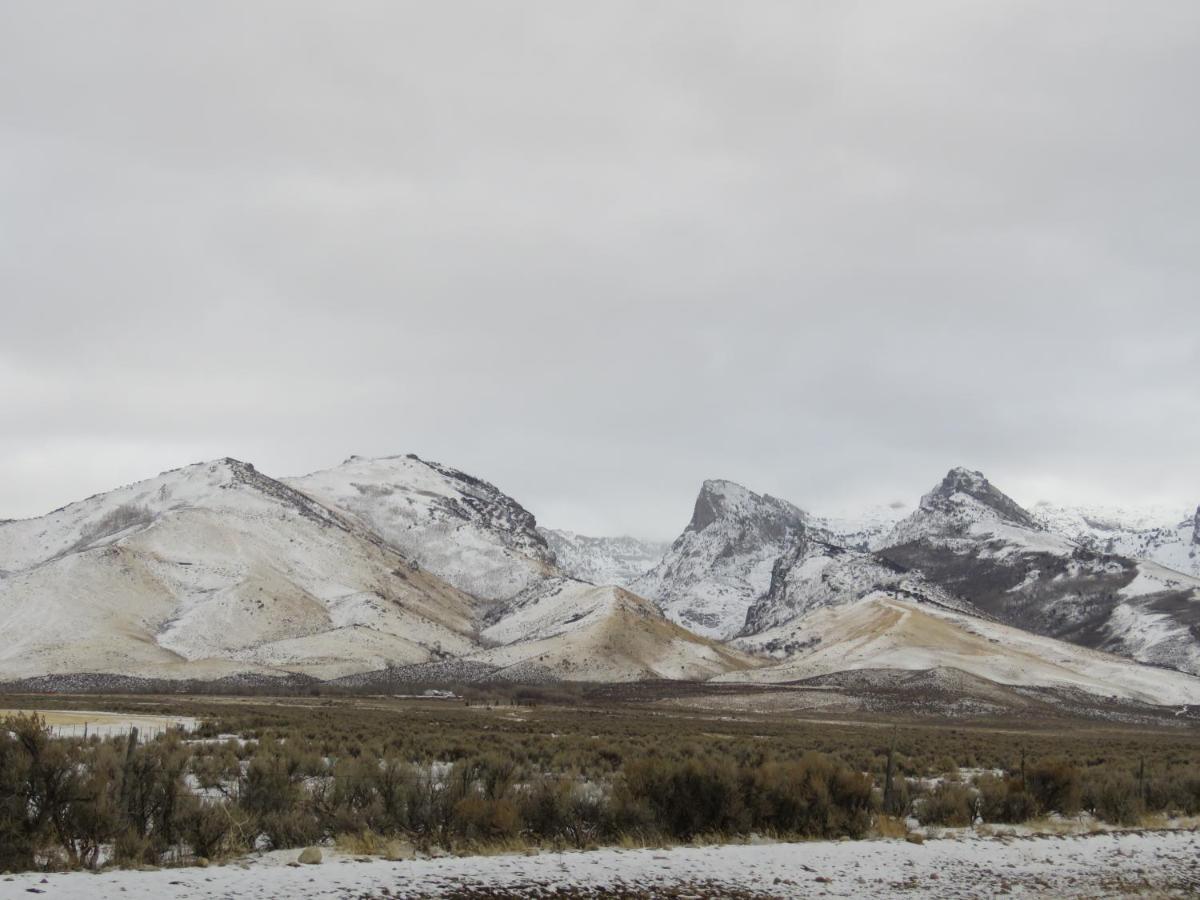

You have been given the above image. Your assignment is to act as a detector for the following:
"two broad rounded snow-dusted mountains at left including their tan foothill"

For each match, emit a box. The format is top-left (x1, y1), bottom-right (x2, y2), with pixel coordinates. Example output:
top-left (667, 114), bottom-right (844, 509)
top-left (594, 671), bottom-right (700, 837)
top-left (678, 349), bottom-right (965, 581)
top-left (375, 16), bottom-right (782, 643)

top-left (0, 457), bottom-right (752, 680)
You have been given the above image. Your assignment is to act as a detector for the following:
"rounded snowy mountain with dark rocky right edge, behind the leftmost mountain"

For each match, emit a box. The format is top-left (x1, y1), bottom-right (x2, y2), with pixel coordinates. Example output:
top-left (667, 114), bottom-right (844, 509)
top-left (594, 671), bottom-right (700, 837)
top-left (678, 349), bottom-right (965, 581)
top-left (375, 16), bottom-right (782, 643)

top-left (284, 455), bottom-right (558, 601)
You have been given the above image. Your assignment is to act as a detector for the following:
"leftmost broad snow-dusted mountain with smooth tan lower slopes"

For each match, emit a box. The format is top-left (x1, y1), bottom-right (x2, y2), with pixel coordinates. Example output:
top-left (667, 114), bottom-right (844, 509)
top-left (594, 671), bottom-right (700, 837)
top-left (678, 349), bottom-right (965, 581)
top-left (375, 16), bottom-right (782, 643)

top-left (0, 458), bottom-right (487, 678)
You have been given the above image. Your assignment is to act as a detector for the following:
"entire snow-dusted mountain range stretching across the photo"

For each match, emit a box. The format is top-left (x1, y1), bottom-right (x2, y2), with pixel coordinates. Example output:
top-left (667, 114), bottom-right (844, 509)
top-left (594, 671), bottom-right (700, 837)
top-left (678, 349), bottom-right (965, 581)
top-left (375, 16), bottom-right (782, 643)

top-left (0, 455), bottom-right (1200, 706)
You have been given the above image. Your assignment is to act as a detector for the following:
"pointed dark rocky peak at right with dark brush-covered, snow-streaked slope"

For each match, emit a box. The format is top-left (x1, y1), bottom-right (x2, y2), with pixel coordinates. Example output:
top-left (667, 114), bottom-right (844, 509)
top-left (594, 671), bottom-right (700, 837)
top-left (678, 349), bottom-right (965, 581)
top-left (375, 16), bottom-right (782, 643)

top-left (876, 469), bottom-right (1200, 673)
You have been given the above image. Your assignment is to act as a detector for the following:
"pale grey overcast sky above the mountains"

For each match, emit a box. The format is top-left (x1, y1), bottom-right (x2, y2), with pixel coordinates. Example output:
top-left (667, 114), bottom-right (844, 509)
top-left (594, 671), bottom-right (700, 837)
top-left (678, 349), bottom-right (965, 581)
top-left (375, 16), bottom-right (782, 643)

top-left (0, 0), bottom-right (1200, 536)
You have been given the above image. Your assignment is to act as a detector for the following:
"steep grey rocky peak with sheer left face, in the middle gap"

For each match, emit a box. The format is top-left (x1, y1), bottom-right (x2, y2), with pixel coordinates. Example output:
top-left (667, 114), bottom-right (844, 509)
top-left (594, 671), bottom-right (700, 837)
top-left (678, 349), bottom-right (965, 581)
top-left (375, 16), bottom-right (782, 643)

top-left (629, 480), bottom-right (805, 640)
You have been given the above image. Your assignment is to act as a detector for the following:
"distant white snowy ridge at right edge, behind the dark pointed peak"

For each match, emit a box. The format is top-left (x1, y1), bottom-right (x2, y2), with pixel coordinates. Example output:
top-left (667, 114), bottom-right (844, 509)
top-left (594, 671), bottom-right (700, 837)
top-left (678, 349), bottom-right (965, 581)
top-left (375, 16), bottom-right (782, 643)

top-left (1032, 503), bottom-right (1200, 577)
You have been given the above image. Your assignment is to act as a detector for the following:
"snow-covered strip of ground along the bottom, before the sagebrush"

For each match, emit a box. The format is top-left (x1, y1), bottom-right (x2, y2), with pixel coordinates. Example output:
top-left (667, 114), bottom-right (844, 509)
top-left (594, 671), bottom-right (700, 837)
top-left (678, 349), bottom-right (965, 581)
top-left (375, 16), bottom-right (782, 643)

top-left (0, 832), bottom-right (1200, 900)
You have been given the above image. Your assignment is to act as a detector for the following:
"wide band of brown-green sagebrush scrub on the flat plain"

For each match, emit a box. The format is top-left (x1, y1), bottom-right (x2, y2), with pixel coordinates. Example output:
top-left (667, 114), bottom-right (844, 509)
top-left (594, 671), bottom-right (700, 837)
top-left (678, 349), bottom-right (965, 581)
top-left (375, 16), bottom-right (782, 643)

top-left (0, 695), bottom-right (1200, 869)
